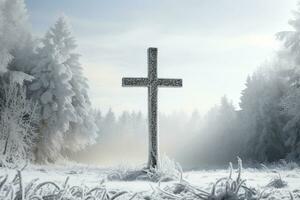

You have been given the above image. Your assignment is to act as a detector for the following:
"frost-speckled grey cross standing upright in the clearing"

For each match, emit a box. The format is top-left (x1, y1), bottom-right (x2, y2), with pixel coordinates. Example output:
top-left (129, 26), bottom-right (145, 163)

top-left (122, 48), bottom-right (182, 169)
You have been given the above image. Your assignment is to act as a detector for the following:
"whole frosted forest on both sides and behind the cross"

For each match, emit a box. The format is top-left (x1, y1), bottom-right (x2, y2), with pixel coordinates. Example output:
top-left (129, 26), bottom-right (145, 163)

top-left (0, 0), bottom-right (300, 168)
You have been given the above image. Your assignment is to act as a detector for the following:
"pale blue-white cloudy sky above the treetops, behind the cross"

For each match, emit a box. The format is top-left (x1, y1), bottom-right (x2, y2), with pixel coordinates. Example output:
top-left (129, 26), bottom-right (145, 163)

top-left (25, 0), bottom-right (297, 113)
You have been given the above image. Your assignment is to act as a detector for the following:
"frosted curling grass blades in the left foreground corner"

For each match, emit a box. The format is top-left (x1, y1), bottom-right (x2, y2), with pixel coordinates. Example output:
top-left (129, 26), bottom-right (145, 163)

top-left (0, 171), bottom-right (130, 200)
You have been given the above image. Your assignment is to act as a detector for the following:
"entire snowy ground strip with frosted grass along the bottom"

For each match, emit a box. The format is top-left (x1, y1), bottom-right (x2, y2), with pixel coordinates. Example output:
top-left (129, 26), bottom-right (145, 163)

top-left (0, 160), bottom-right (300, 200)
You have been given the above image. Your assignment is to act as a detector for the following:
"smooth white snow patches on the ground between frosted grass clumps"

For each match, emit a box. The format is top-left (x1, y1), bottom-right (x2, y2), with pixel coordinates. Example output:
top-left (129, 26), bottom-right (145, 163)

top-left (0, 165), bottom-right (300, 199)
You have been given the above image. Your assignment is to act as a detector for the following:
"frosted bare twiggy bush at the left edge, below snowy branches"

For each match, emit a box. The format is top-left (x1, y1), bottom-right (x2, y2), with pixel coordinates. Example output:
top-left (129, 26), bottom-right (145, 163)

top-left (0, 82), bottom-right (38, 167)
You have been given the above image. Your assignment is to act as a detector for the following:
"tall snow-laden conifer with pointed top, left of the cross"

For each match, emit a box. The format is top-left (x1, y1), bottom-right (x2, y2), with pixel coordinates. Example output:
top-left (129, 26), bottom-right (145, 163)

top-left (30, 17), bottom-right (97, 161)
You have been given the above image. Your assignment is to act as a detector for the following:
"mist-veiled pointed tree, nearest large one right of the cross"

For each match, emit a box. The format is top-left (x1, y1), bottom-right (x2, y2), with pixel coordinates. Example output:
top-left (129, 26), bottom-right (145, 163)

top-left (176, 96), bottom-right (241, 167)
